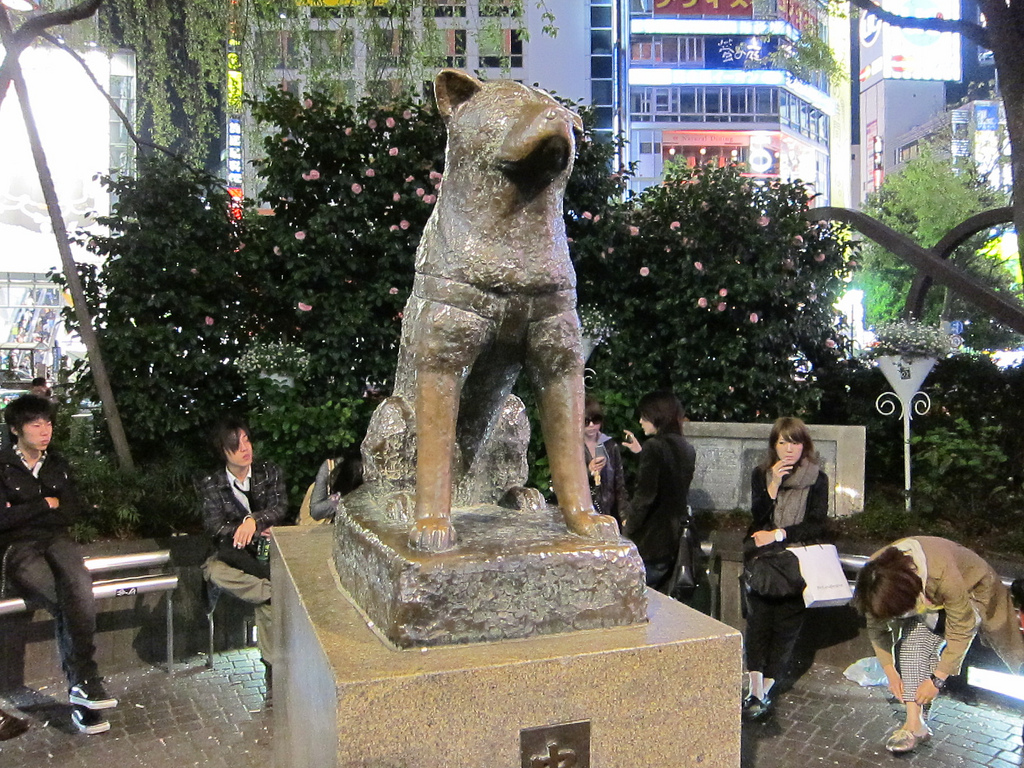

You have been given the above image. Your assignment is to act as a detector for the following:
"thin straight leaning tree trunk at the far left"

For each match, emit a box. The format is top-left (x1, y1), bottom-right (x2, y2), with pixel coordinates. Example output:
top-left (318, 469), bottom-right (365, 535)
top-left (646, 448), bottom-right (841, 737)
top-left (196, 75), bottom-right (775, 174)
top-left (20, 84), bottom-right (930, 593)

top-left (4, 40), bottom-right (134, 470)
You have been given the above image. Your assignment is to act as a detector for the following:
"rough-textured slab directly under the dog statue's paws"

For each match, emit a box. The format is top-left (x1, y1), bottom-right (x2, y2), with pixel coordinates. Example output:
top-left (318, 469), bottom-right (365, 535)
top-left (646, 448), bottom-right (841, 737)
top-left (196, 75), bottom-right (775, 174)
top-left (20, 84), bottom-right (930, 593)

top-left (334, 492), bottom-right (647, 648)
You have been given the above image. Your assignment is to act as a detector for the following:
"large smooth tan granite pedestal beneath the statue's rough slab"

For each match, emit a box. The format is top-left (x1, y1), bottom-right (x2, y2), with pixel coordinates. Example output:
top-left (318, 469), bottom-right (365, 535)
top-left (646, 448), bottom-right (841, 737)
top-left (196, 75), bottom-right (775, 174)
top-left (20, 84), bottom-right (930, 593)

top-left (271, 528), bottom-right (741, 768)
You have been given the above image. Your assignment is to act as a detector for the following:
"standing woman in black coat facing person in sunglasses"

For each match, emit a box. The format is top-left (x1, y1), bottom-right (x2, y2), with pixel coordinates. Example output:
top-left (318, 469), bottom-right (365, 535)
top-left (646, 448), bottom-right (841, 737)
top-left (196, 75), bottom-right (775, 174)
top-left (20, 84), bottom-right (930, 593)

top-left (624, 392), bottom-right (696, 591)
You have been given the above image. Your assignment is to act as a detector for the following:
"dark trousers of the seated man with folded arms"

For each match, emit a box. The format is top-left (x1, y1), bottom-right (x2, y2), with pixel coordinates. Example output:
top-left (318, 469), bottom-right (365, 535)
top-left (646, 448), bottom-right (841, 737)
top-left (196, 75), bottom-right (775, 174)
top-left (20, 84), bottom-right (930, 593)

top-left (4, 537), bottom-right (99, 685)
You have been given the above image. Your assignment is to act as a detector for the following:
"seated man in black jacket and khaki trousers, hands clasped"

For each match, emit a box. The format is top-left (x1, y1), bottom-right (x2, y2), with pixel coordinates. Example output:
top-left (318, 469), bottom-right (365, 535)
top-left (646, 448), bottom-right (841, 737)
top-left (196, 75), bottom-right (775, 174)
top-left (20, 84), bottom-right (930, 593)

top-left (199, 418), bottom-right (288, 685)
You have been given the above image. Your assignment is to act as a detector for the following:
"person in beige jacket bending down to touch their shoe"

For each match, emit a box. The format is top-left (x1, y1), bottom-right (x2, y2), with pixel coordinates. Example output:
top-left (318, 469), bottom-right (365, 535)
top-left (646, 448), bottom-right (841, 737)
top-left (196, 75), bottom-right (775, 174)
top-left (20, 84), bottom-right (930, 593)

top-left (853, 536), bottom-right (1024, 754)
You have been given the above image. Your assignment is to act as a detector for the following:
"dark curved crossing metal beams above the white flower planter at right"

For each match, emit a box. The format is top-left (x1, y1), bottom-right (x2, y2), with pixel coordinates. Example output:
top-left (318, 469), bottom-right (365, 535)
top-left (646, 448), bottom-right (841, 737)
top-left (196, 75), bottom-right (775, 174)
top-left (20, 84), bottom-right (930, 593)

top-left (804, 207), bottom-right (1024, 333)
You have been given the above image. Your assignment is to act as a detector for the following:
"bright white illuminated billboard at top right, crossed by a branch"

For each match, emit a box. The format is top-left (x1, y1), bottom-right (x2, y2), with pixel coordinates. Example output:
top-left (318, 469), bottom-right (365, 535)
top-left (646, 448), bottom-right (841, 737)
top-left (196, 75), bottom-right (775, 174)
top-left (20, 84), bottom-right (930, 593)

top-left (859, 0), bottom-right (963, 83)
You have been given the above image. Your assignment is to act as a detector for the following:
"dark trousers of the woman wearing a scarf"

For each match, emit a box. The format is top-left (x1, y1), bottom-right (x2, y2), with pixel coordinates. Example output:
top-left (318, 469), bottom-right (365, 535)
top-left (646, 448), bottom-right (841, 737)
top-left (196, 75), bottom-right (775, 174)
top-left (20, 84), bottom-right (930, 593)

top-left (744, 592), bottom-right (807, 680)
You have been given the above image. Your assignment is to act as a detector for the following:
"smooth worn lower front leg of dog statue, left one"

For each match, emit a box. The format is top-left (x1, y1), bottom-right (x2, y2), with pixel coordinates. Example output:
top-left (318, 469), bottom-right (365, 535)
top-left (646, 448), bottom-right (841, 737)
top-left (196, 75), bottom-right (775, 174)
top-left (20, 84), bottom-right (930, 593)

top-left (409, 370), bottom-right (461, 552)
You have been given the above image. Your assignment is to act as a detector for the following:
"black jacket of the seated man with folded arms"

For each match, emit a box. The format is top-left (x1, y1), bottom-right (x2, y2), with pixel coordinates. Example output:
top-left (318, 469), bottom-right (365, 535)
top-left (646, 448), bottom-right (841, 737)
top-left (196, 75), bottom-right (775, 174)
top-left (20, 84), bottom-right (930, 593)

top-left (0, 447), bottom-right (80, 550)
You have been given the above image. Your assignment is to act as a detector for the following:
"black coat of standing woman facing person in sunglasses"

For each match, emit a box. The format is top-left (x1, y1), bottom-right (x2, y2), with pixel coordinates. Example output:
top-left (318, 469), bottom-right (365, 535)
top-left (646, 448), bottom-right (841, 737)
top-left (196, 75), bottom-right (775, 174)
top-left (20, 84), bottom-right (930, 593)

top-left (625, 434), bottom-right (697, 563)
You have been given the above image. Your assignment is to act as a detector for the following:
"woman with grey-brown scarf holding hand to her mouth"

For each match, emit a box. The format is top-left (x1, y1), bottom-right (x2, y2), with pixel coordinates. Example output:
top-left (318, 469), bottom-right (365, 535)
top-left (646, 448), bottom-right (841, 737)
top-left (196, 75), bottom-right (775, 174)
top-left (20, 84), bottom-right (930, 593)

top-left (743, 417), bottom-right (828, 720)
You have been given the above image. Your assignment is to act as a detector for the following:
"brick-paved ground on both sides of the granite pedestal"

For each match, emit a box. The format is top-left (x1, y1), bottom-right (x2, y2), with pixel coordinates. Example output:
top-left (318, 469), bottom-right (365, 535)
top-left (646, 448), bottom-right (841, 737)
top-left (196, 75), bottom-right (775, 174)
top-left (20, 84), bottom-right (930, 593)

top-left (0, 650), bottom-right (1024, 768)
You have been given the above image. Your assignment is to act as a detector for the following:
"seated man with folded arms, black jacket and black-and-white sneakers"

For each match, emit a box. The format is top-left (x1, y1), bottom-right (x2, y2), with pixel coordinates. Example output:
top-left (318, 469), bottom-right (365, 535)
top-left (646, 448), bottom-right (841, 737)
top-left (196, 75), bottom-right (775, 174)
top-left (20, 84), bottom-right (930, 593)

top-left (0, 394), bottom-right (118, 734)
